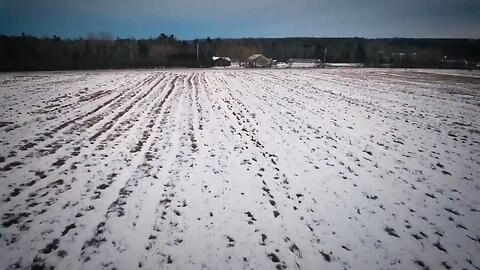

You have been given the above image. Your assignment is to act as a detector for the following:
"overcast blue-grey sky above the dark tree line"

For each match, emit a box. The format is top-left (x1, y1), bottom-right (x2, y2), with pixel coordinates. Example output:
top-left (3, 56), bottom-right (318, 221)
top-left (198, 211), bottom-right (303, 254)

top-left (0, 0), bottom-right (480, 39)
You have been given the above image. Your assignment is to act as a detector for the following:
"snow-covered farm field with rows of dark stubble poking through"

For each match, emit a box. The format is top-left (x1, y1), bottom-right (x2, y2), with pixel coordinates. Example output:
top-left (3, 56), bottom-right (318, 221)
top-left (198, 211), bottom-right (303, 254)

top-left (0, 69), bottom-right (480, 269)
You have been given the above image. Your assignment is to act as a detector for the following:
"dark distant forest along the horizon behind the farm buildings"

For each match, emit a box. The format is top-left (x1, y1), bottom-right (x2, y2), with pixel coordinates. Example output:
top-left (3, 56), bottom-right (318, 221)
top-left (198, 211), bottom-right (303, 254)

top-left (0, 32), bottom-right (480, 71)
